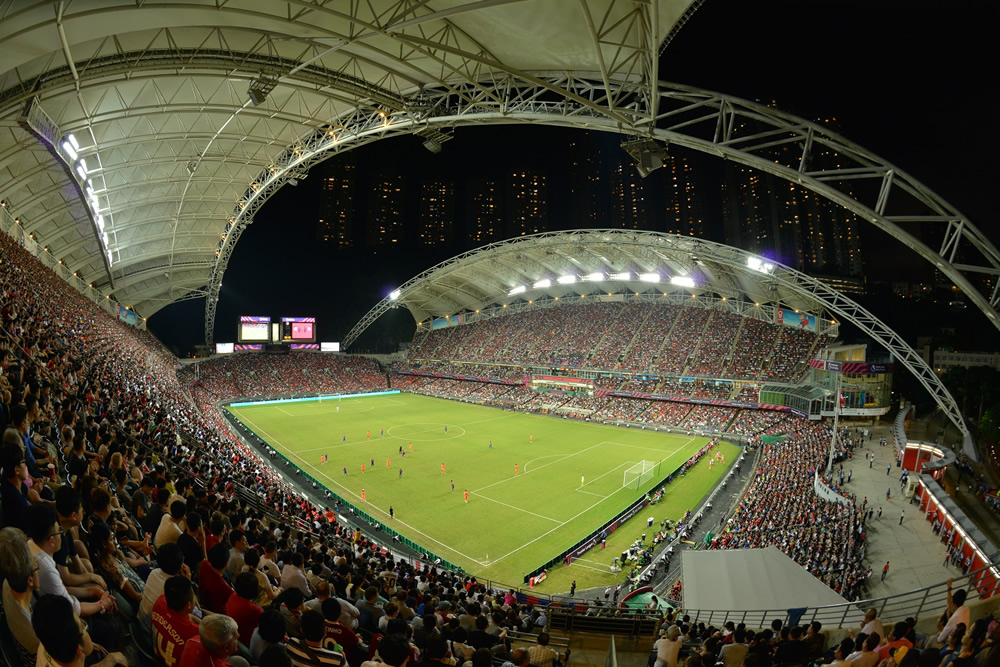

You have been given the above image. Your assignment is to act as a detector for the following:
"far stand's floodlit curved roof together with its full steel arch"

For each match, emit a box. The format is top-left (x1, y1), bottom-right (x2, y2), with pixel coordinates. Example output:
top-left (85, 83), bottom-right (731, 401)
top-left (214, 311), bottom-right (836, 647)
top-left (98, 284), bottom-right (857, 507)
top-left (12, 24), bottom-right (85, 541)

top-left (352, 229), bottom-right (977, 458)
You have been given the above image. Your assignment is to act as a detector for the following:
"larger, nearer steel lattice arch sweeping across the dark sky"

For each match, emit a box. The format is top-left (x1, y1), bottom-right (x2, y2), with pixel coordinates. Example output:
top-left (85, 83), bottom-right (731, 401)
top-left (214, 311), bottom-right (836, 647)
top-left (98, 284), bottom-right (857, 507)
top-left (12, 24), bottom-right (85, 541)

top-left (205, 74), bottom-right (1000, 343)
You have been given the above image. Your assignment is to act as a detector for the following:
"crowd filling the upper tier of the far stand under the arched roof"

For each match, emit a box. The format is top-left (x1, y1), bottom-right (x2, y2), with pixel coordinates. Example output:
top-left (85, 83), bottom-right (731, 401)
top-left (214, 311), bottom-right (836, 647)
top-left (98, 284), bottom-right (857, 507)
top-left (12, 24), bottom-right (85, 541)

top-left (408, 300), bottom-right (819, 381)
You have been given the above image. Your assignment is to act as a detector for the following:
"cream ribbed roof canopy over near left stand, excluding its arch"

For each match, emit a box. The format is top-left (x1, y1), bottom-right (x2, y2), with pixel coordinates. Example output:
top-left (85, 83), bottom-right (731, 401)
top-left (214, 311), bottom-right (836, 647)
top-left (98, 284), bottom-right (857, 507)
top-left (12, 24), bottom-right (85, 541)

top-left (0, 0), bottom-right (702, 320)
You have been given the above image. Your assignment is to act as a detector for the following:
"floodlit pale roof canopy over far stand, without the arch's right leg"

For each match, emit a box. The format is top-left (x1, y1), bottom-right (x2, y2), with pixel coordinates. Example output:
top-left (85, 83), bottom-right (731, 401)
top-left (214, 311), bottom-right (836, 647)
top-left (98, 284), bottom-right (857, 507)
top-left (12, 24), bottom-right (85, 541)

top-left (364, 229), bottom-right (829, 328)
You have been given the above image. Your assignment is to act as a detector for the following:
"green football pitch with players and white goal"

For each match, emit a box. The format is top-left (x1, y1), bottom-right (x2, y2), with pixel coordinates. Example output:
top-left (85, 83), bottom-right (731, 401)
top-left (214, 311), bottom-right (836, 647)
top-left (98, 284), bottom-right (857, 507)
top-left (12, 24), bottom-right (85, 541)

top-left (230, 394), bottom-right (736, 591)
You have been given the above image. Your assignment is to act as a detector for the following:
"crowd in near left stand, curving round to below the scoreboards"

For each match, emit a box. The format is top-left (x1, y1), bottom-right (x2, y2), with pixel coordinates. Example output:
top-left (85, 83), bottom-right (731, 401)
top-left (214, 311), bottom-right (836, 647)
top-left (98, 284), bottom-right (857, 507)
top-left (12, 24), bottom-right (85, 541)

top-left (0, 230), bottom-right (616, 667)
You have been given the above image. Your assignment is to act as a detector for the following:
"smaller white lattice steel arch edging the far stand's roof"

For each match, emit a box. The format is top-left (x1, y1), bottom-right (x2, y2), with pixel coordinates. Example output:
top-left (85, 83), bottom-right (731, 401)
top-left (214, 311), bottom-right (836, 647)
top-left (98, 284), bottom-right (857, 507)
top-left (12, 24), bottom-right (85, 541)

top-left (343, 229), bottom-right (979, 460)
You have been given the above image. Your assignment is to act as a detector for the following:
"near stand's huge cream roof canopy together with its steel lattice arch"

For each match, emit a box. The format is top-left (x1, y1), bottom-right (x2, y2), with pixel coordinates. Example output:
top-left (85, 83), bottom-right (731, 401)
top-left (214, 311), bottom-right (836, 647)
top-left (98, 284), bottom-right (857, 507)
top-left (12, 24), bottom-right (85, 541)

top-left (0, 0), bottom-right (1000, 343)
